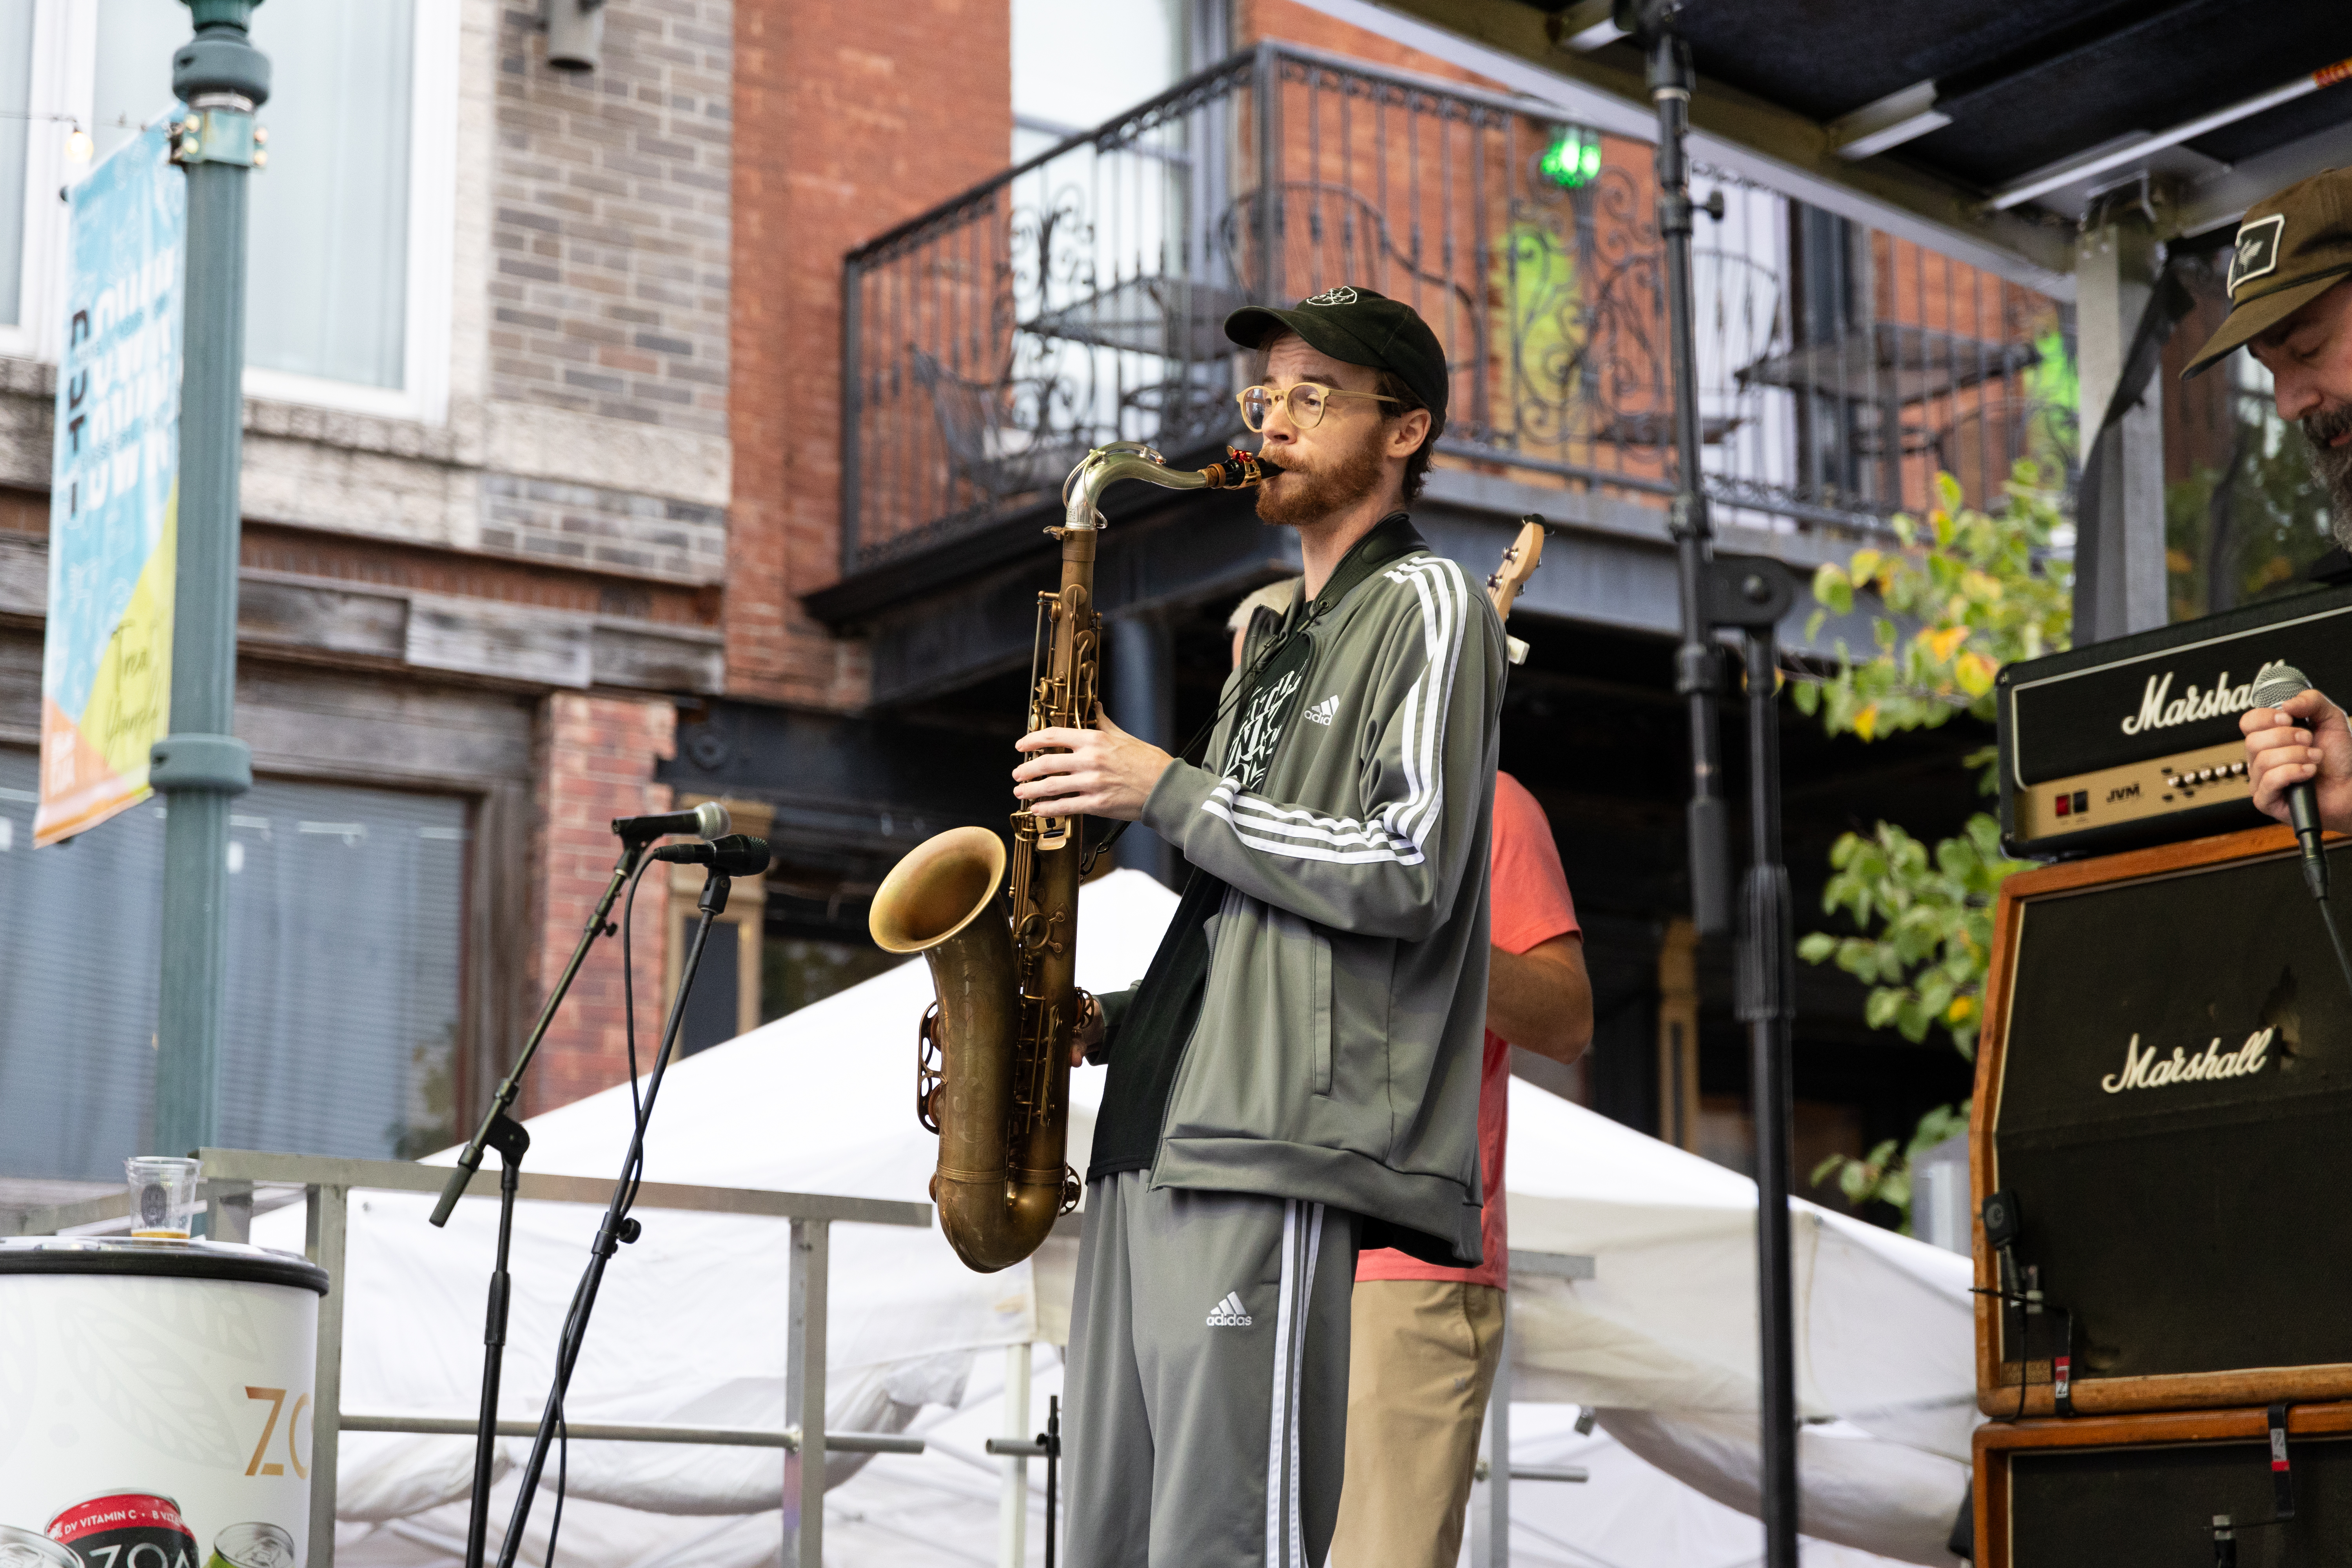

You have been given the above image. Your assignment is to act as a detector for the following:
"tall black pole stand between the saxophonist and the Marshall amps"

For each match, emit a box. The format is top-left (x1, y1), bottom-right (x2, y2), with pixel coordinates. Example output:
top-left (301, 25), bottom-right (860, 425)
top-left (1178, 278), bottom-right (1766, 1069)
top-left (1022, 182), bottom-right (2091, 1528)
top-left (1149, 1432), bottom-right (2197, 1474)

top-left (1616, 0), bottom-right (1797, 1568)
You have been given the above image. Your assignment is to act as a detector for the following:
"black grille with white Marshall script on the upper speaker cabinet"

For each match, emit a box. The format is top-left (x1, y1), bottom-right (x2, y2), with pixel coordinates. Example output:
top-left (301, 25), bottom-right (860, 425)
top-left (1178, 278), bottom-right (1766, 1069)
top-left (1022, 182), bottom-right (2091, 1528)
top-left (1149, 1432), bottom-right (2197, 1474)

top-left (1994, 851), bottom-right (2352, 1380)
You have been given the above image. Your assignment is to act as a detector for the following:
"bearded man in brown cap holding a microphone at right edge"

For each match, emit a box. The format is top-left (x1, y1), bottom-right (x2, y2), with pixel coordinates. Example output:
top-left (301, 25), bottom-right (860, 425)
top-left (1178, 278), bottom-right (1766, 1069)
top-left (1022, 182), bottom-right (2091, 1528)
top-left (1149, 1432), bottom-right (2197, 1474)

top-left (2230, 169), bottom-right (2352, 832)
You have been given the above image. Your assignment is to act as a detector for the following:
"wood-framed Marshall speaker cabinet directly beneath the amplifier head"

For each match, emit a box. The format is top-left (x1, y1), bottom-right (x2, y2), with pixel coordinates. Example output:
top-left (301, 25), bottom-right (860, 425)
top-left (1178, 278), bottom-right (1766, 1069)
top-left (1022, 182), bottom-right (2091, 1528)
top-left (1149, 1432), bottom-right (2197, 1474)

top-left (1969, 827), bottom-right (2352, 1420)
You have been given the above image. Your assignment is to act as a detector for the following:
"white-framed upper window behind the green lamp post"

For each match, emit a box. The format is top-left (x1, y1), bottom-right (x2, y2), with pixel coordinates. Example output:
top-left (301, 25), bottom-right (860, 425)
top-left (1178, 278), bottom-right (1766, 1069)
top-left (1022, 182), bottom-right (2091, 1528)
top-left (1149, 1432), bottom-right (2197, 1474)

top-left (0, 0), bottom-right (456, 421)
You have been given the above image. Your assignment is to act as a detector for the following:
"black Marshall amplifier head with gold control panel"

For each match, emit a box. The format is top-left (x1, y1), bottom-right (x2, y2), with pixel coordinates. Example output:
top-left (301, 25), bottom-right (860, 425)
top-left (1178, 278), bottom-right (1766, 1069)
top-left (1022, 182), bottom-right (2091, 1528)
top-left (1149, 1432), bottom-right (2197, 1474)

top-left (1994, 588), bottom-right (2352, 856)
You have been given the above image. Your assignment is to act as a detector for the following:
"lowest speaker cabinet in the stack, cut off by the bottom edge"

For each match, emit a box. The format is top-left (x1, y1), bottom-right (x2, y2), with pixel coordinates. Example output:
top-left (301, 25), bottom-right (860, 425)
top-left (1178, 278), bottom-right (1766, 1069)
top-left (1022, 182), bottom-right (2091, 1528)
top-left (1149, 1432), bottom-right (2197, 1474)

top-left (1973, 1403), bottom-right (2352, 1568)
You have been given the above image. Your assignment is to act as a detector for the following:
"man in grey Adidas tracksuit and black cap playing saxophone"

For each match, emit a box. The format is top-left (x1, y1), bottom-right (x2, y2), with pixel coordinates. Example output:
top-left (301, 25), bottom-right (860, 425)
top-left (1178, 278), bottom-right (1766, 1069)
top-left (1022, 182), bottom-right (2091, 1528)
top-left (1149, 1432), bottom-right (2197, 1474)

top-left (1014, 287), bottom-right (1505, 1568)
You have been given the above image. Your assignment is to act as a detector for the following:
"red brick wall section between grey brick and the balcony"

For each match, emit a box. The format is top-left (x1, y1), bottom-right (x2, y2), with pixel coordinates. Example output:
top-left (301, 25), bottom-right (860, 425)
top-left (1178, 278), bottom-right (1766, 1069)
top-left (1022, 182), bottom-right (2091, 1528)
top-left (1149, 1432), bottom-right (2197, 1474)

top-left (727, 0), bottom-right (1011, 708)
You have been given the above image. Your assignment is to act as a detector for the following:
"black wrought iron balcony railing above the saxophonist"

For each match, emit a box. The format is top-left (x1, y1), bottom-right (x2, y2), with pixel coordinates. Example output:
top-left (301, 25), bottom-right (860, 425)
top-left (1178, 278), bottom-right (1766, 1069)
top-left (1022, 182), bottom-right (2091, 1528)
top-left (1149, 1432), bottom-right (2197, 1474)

top-left (842, 42), bottom-right (2074, 571)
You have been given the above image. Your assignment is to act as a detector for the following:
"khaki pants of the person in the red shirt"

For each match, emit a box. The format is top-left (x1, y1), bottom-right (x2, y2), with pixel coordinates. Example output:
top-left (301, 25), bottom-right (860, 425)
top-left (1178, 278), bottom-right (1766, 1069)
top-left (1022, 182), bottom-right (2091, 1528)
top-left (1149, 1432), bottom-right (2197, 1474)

top-left (1331, 1279), bottom-right (1503, 1568)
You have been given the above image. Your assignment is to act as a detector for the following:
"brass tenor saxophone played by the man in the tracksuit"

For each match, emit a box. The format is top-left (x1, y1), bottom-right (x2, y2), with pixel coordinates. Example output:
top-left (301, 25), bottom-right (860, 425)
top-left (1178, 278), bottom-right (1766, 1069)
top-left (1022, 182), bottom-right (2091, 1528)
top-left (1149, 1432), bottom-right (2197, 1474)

top-left (868, 442), bottom-right (1279, 1274)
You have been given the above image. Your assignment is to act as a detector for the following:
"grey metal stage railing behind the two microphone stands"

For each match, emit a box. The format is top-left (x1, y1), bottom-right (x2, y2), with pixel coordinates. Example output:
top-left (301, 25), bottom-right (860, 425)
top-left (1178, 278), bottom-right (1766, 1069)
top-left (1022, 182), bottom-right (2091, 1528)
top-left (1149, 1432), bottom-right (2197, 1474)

top-left (12, 1150), bottom-right (931, 1568)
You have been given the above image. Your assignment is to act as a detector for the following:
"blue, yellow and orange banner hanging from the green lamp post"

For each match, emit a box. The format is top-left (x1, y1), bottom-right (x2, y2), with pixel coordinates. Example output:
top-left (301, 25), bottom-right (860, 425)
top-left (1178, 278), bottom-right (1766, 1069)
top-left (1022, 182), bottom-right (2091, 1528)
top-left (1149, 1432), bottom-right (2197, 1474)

top-left (33, 125), bottom-right (188, 844)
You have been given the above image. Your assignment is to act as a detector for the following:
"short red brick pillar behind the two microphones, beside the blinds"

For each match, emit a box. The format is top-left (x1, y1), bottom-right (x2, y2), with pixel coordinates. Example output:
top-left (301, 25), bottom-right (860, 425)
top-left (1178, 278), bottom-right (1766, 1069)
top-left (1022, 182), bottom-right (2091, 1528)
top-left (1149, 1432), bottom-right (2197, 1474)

top-left (522, 691), bottom-right (677, 1117)
